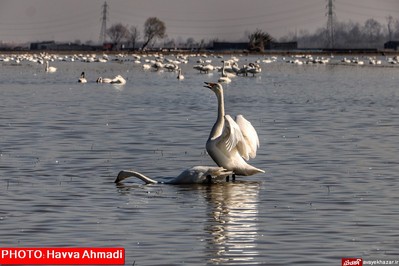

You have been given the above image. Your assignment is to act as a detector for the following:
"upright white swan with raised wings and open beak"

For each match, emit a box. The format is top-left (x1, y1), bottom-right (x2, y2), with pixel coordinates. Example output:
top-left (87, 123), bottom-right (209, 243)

top-left (205, 82), bottom-right (265, 179)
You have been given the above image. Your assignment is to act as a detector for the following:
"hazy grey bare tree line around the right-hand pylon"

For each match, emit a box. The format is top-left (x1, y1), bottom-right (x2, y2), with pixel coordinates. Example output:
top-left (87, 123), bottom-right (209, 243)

top-left (280, 16), bottom-right (399, 49)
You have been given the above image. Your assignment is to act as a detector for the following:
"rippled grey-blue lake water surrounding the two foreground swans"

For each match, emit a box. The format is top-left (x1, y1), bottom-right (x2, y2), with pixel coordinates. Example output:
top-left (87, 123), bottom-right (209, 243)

top-left (0, 53), bottom-right (399, 265)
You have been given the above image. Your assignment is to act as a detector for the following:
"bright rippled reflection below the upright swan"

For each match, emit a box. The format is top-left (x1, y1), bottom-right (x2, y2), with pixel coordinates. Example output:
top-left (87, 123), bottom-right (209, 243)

top-left (205, 182), bottom-right (260, 265)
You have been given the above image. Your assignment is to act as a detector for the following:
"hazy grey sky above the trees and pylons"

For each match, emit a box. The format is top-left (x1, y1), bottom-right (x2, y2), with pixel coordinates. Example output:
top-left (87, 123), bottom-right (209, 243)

top-left (0, 0), bottom-right (399, 42)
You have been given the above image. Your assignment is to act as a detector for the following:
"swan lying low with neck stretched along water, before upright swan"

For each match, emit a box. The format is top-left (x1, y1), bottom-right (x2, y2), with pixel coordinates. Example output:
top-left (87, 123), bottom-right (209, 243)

top-left (115, 166), bottom-right (232, 184)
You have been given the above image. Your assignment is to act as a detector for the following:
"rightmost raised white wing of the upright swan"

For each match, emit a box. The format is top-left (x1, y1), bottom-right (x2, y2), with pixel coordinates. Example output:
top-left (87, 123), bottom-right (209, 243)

top-left (236, 115), bottom-right (259, 160)
